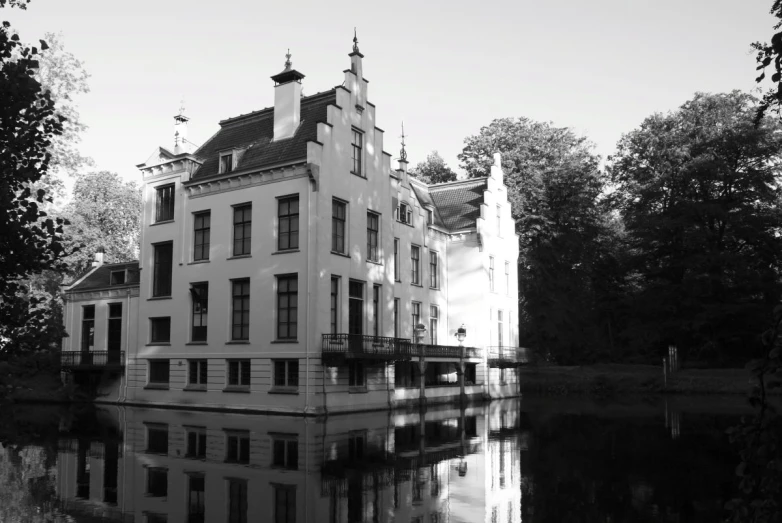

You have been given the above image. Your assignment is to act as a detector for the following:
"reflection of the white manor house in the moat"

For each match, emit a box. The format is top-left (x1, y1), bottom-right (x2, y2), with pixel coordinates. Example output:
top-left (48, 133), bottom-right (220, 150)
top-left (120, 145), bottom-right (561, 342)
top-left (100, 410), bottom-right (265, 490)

top-left (58, 400), bottom-right (523, 523)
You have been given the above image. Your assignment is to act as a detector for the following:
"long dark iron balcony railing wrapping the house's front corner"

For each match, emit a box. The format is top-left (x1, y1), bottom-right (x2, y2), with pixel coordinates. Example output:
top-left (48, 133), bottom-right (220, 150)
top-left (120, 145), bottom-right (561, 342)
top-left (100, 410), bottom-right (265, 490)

top-left (322, 334), bottom-right (480, 361)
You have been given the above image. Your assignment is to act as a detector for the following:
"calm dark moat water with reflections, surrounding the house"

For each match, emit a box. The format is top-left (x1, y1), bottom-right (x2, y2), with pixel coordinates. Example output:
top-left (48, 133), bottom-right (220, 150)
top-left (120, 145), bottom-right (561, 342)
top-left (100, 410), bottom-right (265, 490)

top-left (0, 398), bottom-right (749, 523)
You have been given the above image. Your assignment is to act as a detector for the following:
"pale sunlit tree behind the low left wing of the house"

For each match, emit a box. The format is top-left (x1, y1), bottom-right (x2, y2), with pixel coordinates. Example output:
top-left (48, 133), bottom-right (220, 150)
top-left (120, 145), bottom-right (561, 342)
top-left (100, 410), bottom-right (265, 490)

top-left (65, 171), bottom-right (141, 275)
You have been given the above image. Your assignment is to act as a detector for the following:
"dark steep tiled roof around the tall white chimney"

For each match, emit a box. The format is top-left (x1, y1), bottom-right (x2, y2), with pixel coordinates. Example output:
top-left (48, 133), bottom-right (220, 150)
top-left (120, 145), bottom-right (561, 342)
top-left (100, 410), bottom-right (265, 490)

top-left (193, 89), bottom-right (336, 180)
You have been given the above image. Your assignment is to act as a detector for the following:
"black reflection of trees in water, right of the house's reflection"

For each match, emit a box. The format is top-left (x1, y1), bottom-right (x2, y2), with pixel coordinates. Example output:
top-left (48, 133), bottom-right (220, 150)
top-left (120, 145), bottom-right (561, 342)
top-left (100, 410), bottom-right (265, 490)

top-left (521, 415), bottom-right (736, 523)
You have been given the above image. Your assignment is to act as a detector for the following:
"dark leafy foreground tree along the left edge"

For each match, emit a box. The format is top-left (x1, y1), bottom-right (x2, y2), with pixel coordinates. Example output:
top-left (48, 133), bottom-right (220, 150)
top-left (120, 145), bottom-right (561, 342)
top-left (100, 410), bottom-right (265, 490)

top-left (0, 0), bottom-right (65, 352)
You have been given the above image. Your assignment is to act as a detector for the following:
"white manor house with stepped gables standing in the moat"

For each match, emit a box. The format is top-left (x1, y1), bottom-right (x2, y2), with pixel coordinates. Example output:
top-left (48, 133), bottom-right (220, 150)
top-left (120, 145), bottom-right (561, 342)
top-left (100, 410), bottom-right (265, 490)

top-left (62, 40), bottom-right (525, 415)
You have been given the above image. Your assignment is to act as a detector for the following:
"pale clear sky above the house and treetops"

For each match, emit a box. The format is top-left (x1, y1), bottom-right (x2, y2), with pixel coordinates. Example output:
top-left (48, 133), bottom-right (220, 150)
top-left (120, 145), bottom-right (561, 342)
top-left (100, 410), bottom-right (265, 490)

top-left (0, 0), bottom-right (775, 181)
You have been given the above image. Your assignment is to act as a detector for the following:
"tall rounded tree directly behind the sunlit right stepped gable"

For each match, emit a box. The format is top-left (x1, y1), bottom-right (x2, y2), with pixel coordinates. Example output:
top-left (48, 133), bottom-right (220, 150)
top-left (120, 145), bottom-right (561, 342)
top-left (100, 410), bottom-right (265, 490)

top-left (459, 118), bottom-right (612, 362)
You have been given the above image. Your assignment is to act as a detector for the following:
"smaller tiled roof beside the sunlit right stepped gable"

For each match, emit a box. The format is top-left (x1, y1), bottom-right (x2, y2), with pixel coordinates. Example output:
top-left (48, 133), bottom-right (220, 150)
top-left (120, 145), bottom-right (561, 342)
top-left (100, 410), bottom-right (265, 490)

top-left (429, 178), bottom-right (486, 231)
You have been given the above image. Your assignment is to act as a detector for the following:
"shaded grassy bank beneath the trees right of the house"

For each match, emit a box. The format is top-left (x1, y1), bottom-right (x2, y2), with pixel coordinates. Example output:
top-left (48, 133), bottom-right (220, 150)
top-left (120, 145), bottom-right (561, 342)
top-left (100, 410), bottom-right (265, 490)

top-left (520, 364), bottom-right (776, 397)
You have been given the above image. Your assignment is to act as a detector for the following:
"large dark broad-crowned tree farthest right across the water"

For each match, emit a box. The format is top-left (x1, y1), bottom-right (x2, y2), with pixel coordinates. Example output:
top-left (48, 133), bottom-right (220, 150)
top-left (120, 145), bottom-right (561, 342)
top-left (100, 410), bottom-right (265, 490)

top-left (611, 91), bottom-right (782, 361)
